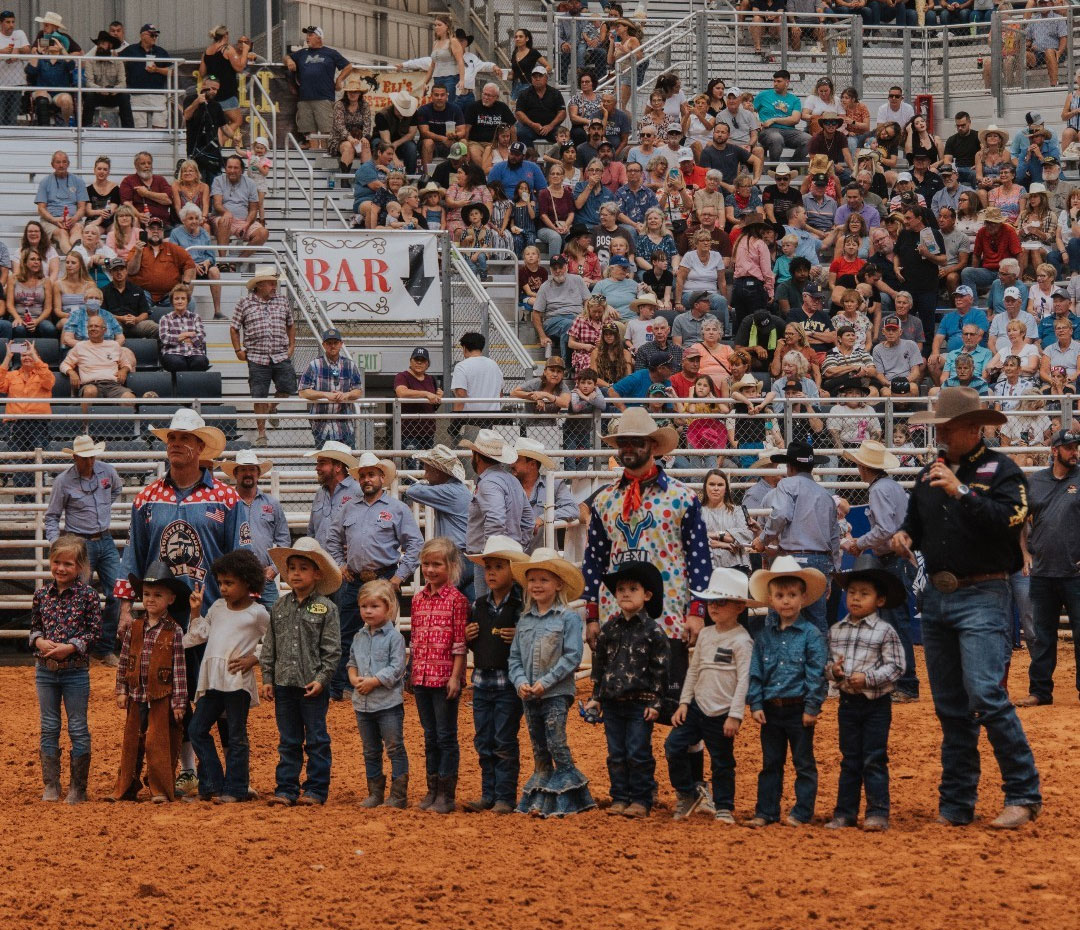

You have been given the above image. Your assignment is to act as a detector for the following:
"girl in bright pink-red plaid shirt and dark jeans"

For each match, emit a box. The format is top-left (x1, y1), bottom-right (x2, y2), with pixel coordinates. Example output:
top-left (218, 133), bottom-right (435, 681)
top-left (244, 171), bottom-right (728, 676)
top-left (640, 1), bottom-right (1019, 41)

top-left (410, 536), bottom-right (469, 813)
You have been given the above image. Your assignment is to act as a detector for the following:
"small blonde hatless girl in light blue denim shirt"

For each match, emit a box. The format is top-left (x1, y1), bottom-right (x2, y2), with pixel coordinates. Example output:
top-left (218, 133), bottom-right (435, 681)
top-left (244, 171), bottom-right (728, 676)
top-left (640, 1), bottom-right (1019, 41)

top-left (346, 578), bottom-right (408, 809)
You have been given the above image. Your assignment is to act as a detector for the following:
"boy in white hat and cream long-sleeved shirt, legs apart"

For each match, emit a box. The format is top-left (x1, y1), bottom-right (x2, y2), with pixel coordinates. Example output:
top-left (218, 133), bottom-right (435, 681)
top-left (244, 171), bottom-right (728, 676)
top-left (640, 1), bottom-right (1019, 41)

top-left (664, 568), bottom-right (760, 823)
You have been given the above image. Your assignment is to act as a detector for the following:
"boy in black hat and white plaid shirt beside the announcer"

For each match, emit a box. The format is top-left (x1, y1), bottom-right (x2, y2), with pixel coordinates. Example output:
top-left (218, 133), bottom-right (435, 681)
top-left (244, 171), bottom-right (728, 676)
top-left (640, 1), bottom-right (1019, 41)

top-left (825, 552), bottom-right (907, 833)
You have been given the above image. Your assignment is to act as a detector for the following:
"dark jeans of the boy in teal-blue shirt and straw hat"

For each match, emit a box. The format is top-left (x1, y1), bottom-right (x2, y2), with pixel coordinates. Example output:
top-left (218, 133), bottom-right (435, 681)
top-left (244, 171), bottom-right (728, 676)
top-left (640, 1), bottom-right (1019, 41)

top-left (754, 704), bottom-right (818, 823)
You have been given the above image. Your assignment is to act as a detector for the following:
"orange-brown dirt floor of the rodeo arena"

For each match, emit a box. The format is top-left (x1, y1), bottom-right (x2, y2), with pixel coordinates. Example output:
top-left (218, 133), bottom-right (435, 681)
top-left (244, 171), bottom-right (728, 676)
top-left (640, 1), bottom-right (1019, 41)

top-left (0, 644), bottom-right (1080, 930)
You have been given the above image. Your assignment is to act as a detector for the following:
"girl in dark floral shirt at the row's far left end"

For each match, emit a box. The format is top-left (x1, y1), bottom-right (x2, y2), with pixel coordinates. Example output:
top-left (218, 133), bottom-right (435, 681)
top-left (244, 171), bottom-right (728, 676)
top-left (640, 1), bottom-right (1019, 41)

top-left (30, 535), bottom-right (102, 804)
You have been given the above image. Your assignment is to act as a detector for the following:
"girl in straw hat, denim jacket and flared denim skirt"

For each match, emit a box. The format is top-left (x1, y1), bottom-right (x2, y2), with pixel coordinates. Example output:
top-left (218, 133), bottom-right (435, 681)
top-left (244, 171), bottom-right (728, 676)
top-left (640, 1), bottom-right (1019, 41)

top-left (508, 547), bottom-right (596, 817)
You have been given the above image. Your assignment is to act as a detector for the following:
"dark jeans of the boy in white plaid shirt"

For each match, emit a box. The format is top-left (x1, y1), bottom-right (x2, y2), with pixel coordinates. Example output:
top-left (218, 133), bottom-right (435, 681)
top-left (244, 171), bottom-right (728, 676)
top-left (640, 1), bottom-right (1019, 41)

top-left (833, 693), bottom-right (892, 820)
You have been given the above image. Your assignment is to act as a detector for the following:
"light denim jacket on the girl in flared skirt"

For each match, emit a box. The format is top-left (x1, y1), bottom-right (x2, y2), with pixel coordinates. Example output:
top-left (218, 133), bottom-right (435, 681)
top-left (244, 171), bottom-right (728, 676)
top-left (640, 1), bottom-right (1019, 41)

top-left (509, 603), bottom-right (584, 698)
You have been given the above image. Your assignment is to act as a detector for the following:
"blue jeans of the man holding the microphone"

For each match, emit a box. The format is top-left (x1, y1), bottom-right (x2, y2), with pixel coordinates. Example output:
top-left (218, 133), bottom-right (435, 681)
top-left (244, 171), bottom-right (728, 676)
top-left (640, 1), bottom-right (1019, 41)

top-left (922, 580), bottom-right (1042, 823)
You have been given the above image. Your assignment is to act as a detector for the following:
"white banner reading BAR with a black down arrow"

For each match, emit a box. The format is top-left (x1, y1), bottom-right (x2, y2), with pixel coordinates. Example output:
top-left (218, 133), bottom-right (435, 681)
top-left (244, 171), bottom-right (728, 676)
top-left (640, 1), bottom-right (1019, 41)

top-left (296, 229), bottom-right (443, 323)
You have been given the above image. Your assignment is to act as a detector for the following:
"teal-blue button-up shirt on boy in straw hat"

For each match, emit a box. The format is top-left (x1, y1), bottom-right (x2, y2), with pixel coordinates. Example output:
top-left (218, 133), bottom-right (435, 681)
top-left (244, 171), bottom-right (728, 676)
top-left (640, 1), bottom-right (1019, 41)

top-left (746, 614), bottom-right (828, 720)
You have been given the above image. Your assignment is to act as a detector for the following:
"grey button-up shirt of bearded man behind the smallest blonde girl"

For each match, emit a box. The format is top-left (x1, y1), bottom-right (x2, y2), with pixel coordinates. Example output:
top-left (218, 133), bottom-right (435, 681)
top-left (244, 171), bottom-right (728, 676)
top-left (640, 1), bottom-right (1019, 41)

top-left (326, 491), bottom-right (423, 580)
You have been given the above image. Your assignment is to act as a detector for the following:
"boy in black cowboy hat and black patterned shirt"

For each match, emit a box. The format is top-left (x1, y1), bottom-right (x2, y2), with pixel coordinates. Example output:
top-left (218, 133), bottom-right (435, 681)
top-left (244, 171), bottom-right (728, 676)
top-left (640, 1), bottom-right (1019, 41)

top-left (585, 561), bottom-right (667, 818)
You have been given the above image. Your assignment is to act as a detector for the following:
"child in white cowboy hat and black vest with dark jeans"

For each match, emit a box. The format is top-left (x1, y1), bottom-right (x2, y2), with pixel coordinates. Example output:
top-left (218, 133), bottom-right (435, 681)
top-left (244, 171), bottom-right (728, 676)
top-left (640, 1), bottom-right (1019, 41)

top-left (464, 536), bottom-right (528, 813)
